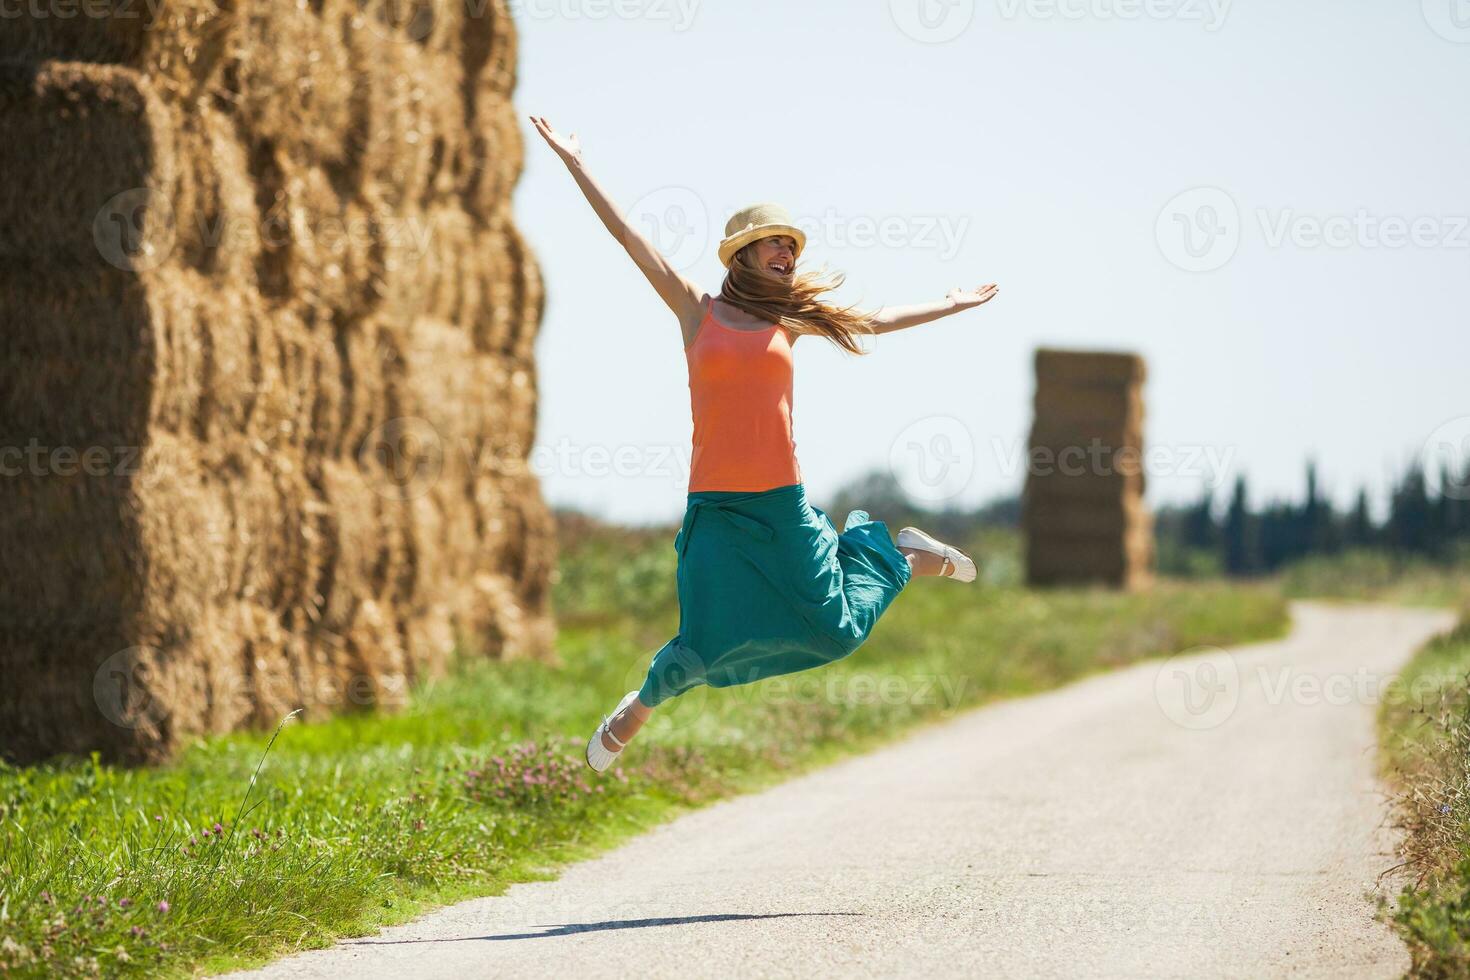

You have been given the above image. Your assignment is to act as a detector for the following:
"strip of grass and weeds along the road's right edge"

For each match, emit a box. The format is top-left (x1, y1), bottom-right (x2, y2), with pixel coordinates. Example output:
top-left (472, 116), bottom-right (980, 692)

top-left (1379, 613), bottom-right (1470, 977)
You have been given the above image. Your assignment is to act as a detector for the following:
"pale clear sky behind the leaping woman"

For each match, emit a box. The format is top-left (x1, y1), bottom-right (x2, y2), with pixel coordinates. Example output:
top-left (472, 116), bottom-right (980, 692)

top-left (512, 0), bottom-right (1470, 522)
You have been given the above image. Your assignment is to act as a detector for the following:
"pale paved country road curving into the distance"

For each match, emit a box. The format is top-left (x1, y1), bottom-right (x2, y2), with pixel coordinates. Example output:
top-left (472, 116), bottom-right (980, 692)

top-left (223, 604), bottom-right (1452, 980)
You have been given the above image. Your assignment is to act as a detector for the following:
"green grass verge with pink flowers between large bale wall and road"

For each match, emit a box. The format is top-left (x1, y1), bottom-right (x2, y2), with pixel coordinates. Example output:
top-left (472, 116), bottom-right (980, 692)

top-left (0, 525), bottom-right (1285, 976)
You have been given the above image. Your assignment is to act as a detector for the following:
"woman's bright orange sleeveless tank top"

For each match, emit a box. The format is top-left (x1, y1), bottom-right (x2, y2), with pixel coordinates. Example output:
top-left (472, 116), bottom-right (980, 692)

top-left (685, 290), bottom-right (801, 494)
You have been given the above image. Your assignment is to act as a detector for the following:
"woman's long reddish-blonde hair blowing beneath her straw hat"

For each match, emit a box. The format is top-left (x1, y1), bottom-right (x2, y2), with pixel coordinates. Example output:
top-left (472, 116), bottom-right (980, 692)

top-left (720, 242), bottom-right (873, 354)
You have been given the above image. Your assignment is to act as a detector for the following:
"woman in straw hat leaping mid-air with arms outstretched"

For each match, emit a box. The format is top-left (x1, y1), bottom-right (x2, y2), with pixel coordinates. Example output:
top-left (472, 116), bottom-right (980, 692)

top-left (531, 116), bottom-right (997, 773)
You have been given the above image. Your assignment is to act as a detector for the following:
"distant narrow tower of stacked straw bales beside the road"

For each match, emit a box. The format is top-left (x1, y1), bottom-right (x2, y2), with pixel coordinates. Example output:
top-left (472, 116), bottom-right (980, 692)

top-left (1022, 350), bottom-right (1154, 589)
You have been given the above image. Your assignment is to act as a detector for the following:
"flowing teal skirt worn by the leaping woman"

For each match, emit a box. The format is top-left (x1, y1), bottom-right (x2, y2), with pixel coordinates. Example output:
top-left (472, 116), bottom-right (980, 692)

top-left (638, 483), bottom-right (913, 707)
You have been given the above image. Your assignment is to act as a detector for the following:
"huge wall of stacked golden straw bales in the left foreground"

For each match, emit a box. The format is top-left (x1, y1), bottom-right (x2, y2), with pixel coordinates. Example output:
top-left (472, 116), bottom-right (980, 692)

top-left (0, 0), bottom-right (554, 761)
